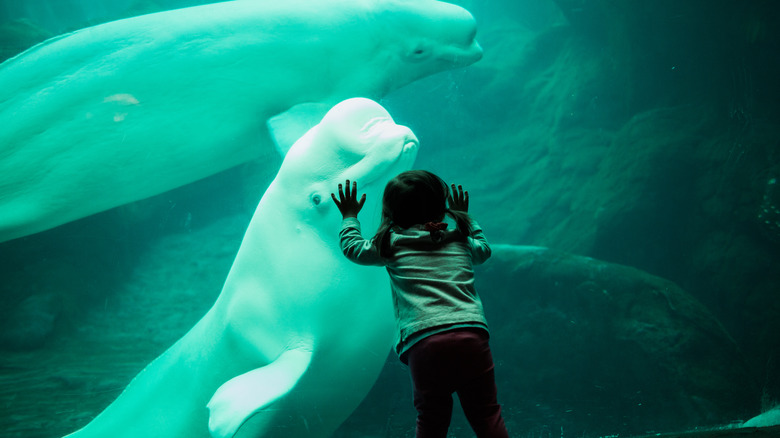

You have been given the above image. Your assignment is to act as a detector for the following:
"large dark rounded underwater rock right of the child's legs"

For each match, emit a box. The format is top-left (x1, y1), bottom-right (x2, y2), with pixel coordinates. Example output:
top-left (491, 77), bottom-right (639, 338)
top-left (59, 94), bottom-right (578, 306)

top-left (477, 245), bottom-right (759, 434)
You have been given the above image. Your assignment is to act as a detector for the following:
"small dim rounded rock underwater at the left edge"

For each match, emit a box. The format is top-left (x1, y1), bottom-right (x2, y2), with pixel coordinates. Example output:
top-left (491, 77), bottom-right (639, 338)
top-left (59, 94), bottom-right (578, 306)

top-left (0, 293), bottom-right (61, 350)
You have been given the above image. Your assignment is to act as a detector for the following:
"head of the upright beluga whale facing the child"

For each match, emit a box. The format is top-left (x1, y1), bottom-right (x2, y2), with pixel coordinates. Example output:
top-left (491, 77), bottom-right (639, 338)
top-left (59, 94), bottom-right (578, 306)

top-left (266, 98), bottom-right (419, 233)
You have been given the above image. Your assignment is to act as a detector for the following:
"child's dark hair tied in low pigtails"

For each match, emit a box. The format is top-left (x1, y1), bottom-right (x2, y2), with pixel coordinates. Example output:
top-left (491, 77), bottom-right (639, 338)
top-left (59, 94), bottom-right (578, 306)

top-left (374, 170), bottom-right (471, 258)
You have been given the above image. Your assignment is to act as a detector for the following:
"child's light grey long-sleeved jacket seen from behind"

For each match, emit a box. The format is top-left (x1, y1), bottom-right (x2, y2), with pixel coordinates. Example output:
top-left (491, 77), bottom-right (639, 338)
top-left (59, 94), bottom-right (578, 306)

top-left (339, 218), bottom-right (490, 355)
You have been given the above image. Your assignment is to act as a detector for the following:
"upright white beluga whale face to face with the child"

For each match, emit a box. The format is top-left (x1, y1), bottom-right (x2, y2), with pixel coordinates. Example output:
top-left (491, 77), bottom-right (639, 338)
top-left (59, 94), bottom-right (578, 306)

top-left (69, 98), bottom-right (418, 438)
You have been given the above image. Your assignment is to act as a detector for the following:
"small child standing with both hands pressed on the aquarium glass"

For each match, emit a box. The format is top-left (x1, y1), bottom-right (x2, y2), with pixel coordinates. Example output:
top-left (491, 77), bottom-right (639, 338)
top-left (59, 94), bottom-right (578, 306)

top-left (331, 170), bottom-right (508, 438)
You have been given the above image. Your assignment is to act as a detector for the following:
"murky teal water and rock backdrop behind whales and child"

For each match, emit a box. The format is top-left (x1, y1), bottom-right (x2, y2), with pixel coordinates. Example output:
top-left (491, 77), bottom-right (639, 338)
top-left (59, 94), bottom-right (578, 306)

top-left (0, 0), bottom-right (780, 437)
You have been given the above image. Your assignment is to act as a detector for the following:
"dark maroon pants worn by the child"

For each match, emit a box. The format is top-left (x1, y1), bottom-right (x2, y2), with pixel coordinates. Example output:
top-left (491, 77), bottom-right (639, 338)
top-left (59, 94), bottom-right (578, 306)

top-left (407, 329), bottom-right (509, 438)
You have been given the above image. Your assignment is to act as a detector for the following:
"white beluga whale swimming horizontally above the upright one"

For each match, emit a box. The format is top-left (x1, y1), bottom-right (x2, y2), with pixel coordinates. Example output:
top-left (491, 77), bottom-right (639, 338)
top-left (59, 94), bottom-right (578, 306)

top-left (0, 0), bottom-right (482, 242)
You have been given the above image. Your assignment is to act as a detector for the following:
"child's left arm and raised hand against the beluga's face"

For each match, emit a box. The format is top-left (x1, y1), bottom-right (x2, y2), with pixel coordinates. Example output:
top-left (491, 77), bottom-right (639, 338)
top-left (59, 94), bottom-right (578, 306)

top-left (330, 180), bottom-right (385, 266)
